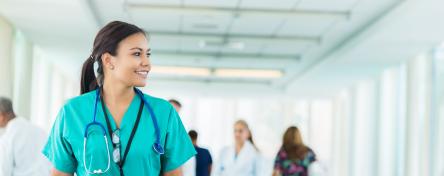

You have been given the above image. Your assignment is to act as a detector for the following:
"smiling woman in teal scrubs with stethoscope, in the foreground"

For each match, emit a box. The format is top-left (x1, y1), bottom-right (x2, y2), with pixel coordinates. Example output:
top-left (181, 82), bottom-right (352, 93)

top-left (43, 21), bottom-right (196, 176)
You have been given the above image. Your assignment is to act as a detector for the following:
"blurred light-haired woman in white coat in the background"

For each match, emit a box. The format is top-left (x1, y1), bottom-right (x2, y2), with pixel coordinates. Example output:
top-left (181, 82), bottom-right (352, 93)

top-left (213, 120), bottom-right (261, 176)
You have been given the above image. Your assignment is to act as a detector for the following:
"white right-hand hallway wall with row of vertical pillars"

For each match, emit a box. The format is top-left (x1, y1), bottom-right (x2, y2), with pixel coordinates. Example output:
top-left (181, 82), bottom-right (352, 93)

top-left (332, 53), bottom-right (444, 176)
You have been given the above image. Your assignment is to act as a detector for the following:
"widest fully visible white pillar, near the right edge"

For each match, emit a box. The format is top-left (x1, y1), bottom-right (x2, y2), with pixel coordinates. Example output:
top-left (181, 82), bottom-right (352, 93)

top-left (406, 55), bottom-right (432, 176)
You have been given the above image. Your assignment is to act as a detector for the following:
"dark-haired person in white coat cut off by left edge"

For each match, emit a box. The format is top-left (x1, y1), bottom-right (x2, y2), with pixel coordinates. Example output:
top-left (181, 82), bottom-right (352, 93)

top-left (0, 97), bottom-right (51, 176)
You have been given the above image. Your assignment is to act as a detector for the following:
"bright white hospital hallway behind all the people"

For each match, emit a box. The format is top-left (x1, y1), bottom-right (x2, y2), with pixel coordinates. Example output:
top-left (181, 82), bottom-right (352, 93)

top-left (0, 0), bottom-right (444, 176)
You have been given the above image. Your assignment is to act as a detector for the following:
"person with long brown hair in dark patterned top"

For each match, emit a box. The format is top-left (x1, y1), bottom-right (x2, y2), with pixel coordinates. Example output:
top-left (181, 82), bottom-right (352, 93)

top-left (273, 126), bottom-right (316, 176)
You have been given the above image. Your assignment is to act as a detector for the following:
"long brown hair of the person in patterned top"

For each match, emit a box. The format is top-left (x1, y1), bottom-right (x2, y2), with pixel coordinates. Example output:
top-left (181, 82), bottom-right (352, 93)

top-left (282, 126), bottom-right (310, 160)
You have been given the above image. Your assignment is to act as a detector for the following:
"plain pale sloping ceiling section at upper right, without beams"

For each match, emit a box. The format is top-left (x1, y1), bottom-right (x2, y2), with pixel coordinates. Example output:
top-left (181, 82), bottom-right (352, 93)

top-left (287, 0), bottom-right (444, 94)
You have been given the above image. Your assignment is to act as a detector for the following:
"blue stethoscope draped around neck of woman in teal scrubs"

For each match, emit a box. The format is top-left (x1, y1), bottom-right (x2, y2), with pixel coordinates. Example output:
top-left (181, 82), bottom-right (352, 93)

top-left (83, 88), bottom-right (165, 174)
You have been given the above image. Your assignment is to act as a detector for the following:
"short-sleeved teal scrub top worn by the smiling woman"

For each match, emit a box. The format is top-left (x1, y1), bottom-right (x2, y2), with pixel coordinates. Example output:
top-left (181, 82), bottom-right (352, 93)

top-left (43, 91), bottom-right (196, 176)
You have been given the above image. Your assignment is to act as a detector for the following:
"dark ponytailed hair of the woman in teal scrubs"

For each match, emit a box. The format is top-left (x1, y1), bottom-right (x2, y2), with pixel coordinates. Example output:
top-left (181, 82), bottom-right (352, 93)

top-left (80, 21), bottom-right (146, 94)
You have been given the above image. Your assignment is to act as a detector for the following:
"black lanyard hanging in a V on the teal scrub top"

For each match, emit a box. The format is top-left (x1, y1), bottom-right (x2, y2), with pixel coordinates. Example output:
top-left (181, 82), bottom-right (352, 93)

top-left (100, 95), bottom-right (143, 176)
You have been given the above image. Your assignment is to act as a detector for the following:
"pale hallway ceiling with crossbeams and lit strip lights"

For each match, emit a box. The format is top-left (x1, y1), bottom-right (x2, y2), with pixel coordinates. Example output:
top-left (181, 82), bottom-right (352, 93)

top-left (0, 0), bottom-right (400, 89)
